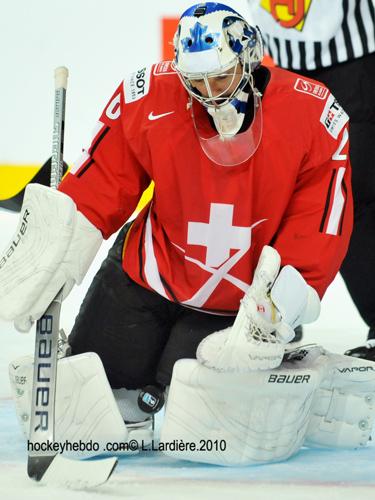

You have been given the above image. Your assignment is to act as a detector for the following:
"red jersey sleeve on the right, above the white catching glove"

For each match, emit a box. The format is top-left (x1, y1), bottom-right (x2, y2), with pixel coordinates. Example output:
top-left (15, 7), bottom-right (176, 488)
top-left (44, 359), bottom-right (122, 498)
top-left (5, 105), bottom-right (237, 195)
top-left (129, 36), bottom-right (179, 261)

top-left (273, 109), bottom-right (353, 297)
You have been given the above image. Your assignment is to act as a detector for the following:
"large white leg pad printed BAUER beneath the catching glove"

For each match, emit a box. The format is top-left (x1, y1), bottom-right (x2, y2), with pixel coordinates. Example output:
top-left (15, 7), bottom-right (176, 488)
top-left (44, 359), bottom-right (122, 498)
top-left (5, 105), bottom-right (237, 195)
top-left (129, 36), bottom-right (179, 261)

top-left (161, 359), bottom-right (320, 465)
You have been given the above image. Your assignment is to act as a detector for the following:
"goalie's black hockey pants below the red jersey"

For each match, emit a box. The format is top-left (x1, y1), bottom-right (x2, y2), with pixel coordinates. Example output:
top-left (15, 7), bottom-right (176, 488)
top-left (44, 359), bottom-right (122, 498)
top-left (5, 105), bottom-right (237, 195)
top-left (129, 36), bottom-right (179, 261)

top-left (69, 229), bottom-right (235, 389)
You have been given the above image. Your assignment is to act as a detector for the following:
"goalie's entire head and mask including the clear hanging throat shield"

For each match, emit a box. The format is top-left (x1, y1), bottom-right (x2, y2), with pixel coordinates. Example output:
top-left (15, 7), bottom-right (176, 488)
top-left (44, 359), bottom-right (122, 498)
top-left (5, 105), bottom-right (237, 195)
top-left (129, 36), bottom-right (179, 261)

top-left (173, 2), bottom-right (263, 166)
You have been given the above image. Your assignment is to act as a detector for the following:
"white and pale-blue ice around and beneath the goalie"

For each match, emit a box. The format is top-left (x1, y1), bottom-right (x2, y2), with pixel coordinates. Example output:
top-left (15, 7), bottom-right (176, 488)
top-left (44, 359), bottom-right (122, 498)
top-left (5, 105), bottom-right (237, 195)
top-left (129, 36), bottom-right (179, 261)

top-left (0, 211), bottom-right (375, 500)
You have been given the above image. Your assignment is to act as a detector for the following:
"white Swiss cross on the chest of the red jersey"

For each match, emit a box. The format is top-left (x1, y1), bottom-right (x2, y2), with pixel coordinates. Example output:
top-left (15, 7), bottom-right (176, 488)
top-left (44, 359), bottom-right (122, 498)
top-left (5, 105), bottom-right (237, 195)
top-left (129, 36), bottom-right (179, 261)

top-left (187, 203), bottom-right (252, 267)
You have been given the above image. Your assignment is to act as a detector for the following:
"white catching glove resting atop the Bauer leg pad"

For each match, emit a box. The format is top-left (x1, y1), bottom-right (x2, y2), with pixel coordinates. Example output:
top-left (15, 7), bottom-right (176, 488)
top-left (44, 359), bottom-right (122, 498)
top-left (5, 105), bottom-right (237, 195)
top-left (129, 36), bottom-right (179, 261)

top-left (197, 246), bottom-right (320, 372)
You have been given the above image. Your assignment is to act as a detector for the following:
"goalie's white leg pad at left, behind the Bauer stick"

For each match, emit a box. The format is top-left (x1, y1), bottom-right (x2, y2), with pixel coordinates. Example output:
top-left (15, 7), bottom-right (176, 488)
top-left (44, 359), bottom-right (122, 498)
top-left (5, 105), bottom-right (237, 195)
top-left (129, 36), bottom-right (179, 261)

top-left (9, 353), bottom-right (153, 457)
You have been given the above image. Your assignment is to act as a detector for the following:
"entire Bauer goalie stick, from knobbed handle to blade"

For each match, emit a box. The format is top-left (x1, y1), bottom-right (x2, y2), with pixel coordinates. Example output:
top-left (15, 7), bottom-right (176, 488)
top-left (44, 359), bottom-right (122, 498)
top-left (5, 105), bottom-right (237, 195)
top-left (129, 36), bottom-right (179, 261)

top-left (27, 67), bottom-right (117, 488)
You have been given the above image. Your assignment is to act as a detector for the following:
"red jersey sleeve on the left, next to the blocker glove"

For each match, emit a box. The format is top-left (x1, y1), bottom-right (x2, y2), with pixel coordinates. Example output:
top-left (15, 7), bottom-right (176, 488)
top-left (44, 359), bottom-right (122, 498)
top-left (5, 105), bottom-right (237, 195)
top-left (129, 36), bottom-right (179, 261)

top-left (59, 84), bottom-right (150, 238)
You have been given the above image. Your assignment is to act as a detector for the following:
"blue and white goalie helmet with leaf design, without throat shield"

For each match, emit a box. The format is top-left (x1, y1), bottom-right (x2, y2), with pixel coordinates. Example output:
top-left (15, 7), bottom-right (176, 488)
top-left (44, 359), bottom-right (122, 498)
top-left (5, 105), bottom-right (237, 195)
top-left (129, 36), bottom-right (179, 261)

top-left (173, 2), bottom-right (263, 106)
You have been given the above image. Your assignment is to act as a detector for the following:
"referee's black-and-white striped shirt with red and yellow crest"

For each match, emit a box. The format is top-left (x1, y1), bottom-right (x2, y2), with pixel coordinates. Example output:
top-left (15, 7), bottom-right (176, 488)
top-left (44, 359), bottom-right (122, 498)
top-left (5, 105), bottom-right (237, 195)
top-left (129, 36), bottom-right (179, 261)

top-left (248, 0), bottom-right (375, 70)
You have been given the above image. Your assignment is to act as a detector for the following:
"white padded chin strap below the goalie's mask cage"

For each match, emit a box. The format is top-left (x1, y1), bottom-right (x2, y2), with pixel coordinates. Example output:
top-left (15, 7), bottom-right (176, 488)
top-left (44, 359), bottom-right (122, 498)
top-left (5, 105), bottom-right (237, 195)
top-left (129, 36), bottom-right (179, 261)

top-left (207, 90), bottom-right (249, 139)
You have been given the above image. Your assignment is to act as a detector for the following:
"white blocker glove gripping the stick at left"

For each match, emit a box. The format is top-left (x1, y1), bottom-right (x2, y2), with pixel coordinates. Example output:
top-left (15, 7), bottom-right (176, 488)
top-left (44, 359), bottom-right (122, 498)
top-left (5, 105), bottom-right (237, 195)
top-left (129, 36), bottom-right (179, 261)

top-left (0, 184), bottom-right (103, 332)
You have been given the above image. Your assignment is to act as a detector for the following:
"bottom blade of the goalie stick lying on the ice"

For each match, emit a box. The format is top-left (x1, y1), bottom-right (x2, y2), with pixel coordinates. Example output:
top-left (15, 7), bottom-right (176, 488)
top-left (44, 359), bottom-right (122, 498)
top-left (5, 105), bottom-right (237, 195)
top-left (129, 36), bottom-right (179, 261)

top-left (28, 455), bottom-right (118, 489)
